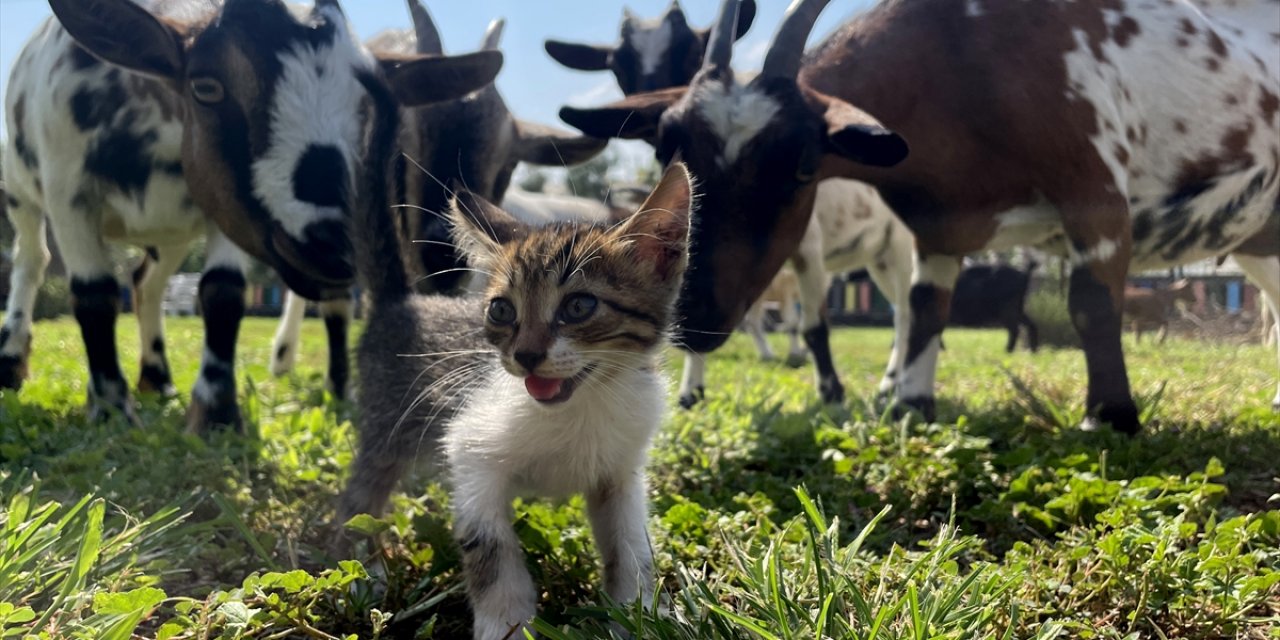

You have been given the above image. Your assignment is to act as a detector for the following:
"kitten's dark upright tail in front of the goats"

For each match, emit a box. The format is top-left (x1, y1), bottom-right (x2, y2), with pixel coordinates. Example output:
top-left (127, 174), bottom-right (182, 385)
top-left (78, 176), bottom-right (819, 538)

top-left (351, 73), bottom-right (410, 307)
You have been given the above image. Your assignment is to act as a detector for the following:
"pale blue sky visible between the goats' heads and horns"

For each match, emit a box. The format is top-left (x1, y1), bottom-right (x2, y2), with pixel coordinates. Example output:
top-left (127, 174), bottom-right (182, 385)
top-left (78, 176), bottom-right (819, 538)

top-left (0, 0), bottom-right (869, 144)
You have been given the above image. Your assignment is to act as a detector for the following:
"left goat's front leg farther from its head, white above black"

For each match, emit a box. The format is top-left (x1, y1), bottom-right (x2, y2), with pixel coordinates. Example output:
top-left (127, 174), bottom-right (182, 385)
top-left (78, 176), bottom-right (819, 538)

top-left (50, 206), bottom-right (141, 425)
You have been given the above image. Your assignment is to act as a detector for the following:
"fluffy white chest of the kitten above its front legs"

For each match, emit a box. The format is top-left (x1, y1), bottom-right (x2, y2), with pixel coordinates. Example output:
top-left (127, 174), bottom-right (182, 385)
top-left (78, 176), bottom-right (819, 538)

top-left (445, 371), bottom-right (666, 497)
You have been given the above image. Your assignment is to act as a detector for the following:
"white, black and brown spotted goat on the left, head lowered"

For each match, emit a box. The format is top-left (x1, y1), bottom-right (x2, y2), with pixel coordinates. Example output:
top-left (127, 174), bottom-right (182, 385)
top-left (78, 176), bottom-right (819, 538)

top-left (0, 0), bottom-right (502, 433)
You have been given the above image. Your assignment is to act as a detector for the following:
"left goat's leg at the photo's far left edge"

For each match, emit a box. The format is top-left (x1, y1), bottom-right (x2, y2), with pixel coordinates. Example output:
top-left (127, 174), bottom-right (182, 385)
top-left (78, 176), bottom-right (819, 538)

top-left (0, 197), bottom-right (50, 389)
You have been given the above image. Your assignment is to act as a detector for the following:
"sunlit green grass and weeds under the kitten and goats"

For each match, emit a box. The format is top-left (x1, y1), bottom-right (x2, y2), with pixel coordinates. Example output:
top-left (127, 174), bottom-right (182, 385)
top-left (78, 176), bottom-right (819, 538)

top-left (0, 319), bottom-right (1280, 640)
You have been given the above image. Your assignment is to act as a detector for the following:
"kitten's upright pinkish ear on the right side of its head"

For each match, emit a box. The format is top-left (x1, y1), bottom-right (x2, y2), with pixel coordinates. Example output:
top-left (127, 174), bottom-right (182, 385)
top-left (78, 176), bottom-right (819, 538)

top-left (614, 163), bottom-right (694, 280)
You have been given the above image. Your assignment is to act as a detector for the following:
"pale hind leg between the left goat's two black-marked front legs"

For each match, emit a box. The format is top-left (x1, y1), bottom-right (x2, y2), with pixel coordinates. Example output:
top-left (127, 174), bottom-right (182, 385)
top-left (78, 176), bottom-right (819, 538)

top-left (133, 244), bottom-right (187, 398)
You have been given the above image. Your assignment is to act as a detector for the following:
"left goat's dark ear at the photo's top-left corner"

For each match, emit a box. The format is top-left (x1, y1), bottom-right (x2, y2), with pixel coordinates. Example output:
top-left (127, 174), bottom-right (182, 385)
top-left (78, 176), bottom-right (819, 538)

top-left (49, 0), bottom-right (188, 82)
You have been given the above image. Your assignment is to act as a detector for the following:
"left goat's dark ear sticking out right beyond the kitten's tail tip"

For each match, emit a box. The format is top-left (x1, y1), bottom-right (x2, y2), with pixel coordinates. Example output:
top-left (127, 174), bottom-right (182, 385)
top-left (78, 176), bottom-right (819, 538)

top-left (374, 51), bottom-right (502, 106)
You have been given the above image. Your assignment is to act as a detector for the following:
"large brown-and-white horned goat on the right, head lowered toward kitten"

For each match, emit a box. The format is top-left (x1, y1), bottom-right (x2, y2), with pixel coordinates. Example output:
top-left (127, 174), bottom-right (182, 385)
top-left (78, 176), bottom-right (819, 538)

top-left (561, 0), bottom-right (1280, 433)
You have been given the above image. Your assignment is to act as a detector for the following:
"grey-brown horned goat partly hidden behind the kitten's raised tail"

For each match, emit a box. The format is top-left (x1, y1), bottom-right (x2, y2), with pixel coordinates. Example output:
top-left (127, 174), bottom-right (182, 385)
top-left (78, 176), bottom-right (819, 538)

top-left (271, 0), bottom-right (608, 386)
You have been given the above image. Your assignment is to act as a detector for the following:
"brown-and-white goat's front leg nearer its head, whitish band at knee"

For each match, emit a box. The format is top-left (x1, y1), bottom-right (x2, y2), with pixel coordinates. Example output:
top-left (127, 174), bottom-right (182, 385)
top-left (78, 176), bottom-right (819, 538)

top-left (897, 252), bottom-right (960, 421)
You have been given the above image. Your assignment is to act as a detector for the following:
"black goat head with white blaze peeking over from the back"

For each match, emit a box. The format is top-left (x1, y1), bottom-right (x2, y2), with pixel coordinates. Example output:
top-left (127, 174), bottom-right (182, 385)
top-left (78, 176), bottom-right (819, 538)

top-left (544, 0), bottom-right (755, 95)
